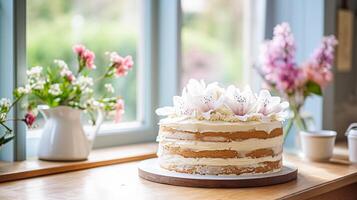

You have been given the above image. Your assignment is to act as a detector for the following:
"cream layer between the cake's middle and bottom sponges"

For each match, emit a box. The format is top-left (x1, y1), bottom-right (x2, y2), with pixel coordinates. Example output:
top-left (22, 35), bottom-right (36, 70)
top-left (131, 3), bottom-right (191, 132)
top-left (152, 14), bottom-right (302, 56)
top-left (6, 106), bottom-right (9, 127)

top-left (159, 154), bottom-right (282, 166)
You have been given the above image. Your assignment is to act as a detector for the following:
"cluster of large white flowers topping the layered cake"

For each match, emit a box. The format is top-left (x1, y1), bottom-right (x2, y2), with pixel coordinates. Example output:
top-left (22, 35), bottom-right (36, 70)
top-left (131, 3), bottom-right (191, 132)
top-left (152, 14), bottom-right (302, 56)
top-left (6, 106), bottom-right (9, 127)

top-left (156, 79), bottom-right (289, 122)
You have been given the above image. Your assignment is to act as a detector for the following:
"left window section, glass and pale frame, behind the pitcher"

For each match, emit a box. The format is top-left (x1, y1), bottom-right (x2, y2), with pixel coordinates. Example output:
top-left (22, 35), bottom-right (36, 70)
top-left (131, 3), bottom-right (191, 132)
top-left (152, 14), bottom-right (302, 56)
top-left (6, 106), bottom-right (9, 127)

top-left (26, 0), bottom-right (154, 156)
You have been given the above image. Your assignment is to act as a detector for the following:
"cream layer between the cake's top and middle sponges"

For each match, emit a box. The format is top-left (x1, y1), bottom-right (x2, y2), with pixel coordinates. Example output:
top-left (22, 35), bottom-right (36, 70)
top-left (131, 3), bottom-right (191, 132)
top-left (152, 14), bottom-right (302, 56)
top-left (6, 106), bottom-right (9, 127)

top-left (158, 135), bottom-right (283, 151)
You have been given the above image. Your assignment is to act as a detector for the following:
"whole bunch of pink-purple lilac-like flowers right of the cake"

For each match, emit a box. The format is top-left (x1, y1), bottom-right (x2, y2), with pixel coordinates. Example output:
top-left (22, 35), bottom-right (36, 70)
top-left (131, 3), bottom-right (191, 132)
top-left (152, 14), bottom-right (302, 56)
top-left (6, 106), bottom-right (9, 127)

top-left (257, 23), bottom-right (337, 136)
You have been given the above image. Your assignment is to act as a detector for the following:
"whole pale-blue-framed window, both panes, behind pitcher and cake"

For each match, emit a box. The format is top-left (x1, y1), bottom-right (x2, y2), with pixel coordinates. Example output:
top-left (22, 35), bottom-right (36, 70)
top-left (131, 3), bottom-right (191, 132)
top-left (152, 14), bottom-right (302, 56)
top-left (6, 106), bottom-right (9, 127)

top-left (0, 0), bottom-right (265, 159)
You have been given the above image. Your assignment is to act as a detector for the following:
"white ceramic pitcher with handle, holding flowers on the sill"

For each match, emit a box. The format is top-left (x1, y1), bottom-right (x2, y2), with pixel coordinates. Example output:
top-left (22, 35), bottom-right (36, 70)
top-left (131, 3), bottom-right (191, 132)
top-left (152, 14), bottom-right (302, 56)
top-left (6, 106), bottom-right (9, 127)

top-left (38, 106), bottom-right (103, 161)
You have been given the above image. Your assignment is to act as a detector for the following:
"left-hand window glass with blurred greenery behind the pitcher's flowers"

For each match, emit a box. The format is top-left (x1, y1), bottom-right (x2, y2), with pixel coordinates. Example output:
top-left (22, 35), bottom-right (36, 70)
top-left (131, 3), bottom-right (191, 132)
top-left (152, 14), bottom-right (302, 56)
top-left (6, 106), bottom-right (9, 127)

top-left (27, 0), bottom-right (140, 124)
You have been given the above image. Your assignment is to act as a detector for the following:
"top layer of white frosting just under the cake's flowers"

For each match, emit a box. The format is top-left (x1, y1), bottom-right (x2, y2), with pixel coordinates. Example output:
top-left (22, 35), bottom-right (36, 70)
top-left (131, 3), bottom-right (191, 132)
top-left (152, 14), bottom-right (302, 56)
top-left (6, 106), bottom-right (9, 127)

top-left (159, 118), bottom-right (282, 133)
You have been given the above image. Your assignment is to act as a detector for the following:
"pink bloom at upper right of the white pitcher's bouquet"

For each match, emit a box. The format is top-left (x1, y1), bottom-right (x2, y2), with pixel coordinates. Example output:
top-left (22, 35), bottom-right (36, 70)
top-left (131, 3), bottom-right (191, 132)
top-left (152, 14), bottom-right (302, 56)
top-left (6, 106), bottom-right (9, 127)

top-left (110, 52), bottom-right (134, 76)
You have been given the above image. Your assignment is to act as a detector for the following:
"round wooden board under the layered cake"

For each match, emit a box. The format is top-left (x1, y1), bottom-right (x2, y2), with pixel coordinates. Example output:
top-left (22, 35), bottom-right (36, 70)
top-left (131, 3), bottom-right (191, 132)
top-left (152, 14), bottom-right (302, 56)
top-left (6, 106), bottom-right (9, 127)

top-left (139, 158), bottom-right (297, 188)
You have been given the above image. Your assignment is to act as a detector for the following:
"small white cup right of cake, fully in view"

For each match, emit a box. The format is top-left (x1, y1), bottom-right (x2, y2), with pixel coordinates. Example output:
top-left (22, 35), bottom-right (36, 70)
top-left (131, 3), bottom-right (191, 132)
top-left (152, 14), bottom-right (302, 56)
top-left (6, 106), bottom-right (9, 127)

top-left (300, 130), bottom-right (337, 161)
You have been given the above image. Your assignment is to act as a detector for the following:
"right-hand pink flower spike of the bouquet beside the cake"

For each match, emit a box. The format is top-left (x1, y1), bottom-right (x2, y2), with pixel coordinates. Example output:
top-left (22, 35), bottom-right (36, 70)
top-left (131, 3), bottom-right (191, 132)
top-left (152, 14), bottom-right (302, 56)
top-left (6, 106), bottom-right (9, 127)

top-left (303, 36), bottom-right (337, 87)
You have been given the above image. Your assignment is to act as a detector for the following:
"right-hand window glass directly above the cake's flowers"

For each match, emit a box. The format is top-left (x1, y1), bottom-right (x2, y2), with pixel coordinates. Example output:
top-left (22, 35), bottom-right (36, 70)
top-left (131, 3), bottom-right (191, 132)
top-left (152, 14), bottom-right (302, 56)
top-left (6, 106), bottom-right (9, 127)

top-left (181, 0), bottom-right (244, 86)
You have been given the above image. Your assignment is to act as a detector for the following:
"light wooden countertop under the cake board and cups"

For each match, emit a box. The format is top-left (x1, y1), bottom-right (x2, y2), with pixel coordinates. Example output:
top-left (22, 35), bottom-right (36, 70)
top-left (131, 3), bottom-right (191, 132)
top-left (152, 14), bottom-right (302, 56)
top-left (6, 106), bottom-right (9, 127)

top-left (0, 144), bottom-right (357, 200)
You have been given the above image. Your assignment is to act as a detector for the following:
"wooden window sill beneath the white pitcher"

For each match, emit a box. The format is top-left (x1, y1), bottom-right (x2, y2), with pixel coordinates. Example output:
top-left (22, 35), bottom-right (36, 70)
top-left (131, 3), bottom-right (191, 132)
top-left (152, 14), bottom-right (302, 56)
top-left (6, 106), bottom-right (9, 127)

top-left (0, 143), bottom-right (157, 182)
